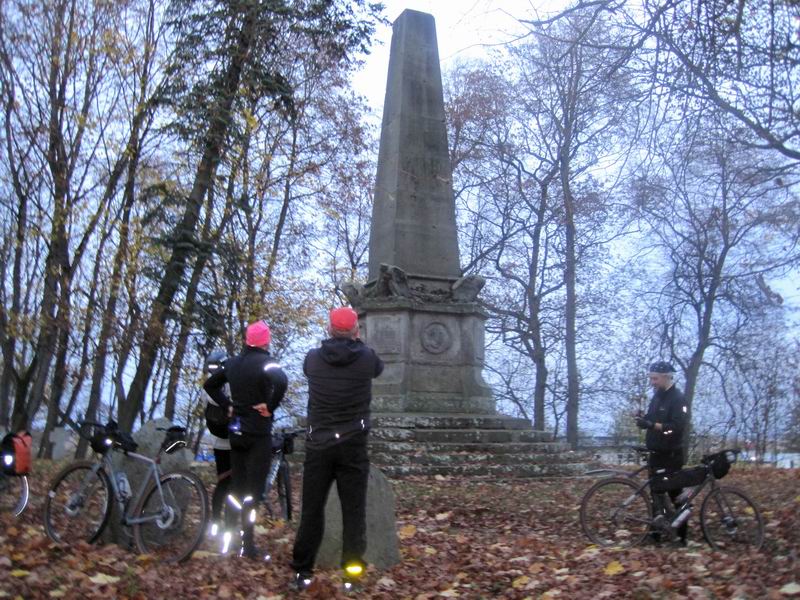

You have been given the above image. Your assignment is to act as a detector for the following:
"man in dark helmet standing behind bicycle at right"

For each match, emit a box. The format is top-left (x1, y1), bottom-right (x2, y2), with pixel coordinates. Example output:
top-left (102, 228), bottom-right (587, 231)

top-left (636, 361), bottom-right (688, 545)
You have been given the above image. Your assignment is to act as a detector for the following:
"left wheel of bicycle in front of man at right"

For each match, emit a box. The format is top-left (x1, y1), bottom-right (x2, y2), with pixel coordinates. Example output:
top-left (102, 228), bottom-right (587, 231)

top-left (580, 477), bottom-right (651, 546)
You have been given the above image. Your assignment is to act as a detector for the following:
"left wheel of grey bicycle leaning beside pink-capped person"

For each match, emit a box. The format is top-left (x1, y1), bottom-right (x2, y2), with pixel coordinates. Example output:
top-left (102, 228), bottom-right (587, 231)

top-left (44, 461), bottom-right (113, 544)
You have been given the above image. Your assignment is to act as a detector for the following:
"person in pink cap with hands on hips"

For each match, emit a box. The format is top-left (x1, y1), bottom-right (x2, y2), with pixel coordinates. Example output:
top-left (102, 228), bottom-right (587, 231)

top-left (203, 321), bottom-right (287, 560)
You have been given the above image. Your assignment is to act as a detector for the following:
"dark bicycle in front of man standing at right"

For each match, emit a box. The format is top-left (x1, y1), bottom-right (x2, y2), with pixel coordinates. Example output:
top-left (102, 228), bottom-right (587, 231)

top-left (580, 448), bottom-right (764, 551)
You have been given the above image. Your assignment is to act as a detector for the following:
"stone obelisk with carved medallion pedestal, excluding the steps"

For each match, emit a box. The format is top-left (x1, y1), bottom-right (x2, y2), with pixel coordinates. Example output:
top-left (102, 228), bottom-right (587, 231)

top-left (349, 10), bottom-right (495, 414)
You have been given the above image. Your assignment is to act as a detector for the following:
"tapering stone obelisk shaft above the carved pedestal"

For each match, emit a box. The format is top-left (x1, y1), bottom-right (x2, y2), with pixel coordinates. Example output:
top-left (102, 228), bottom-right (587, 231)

top-left (369, 4), bottom-right (461, 283)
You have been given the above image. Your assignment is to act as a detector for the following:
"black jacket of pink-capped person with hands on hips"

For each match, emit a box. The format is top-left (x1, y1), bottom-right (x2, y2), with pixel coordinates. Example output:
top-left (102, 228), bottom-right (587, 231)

top-left (203, 346), bottom-right (288, 435)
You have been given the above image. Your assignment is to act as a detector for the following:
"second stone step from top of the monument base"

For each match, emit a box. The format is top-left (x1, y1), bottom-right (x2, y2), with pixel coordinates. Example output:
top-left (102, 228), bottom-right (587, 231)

top-left (370, 426), bottom-right (553, 443)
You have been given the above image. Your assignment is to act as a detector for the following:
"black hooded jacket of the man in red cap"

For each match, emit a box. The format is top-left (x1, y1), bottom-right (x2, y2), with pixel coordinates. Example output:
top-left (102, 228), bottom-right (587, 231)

top-left (303, 338), bottom-right (383, 447)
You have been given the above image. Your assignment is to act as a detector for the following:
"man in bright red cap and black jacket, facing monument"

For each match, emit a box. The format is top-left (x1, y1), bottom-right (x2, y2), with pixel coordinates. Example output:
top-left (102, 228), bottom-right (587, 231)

top-left (292, 308), bottom-right (383, 589)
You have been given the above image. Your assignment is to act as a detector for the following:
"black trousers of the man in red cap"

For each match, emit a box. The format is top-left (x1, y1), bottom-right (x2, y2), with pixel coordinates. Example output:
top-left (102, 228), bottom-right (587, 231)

top-left (292, 432), bottom-right (369, 573)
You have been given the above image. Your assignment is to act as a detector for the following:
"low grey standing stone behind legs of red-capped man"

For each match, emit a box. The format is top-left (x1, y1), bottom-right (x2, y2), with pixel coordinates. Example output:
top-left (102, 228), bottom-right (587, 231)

top-left (317, 465), bottom-right (400, 569)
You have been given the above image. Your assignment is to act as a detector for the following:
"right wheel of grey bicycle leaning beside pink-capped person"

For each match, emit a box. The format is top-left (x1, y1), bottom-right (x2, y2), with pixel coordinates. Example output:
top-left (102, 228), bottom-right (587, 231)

top-left (133, 471), bottom-right (208, 563)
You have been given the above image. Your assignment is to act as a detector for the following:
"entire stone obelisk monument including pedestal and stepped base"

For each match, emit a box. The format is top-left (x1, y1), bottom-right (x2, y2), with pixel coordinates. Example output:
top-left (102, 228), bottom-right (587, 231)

top-left (342, 10), bottom-right (582, 476)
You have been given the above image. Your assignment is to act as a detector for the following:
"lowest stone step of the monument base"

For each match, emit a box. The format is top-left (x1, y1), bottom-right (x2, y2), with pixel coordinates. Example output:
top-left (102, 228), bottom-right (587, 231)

top-left (375, 463), bottom-right (587, 479)
